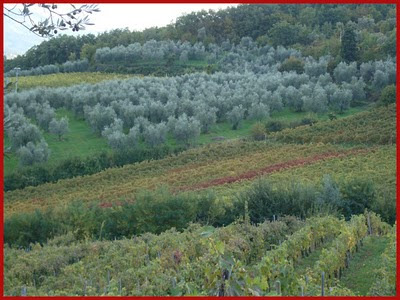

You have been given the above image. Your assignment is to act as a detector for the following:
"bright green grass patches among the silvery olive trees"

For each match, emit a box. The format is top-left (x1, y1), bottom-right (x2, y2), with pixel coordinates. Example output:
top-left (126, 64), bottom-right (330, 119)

top-left (4, 107), bottom-right (366, 175)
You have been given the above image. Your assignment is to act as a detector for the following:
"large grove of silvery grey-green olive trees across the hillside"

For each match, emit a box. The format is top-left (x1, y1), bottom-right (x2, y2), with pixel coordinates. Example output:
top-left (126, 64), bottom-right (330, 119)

top-left (5, 55), bottom-right (396, 155)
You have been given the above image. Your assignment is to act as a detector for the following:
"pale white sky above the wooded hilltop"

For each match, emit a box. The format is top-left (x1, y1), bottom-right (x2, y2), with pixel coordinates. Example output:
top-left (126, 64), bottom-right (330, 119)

top-left (3, 4), bottom-right (236, 58)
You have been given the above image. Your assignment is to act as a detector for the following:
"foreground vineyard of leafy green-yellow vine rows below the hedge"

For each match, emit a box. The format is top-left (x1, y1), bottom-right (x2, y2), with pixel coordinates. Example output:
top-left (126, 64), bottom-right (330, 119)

top-left (4, 213), bottom-right (395, 296)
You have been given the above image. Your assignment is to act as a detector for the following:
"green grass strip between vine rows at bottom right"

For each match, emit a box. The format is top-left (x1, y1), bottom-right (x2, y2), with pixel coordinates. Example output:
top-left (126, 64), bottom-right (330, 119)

top-left (340, 236), bottom-right (388, 295)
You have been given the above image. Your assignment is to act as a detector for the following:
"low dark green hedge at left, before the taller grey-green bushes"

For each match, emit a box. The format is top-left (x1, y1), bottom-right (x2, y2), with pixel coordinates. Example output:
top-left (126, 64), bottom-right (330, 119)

top-left (4, 190), bottom-right (219, 247)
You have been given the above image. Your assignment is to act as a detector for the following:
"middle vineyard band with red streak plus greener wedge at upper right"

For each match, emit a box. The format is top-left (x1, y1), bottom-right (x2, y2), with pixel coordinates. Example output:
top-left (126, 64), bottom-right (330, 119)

top-left (4, 105), bottom-right (396, 217)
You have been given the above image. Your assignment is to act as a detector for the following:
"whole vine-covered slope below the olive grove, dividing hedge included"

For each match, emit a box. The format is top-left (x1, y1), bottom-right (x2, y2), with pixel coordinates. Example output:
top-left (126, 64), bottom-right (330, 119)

top-left (4, 106), bottom-right (396, 295)
